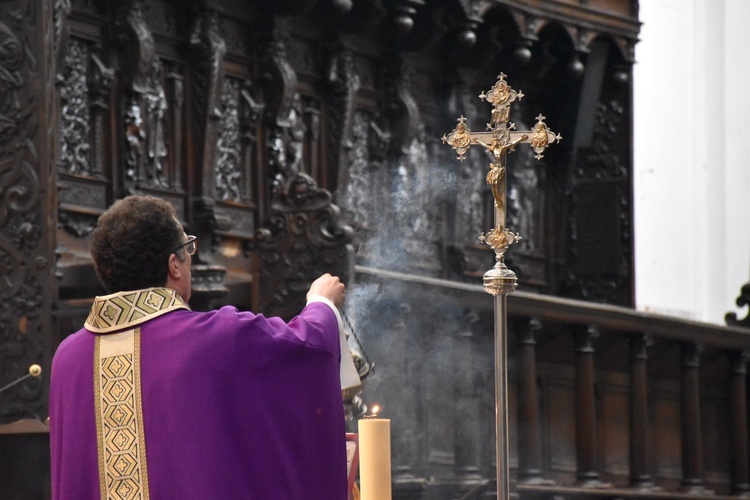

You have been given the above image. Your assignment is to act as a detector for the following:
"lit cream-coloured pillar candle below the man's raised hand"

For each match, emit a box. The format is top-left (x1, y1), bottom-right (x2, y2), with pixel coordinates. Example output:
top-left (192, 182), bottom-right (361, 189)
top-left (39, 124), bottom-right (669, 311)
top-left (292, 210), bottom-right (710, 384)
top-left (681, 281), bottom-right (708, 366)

top-left (359, 418), bottom-right (391, 500)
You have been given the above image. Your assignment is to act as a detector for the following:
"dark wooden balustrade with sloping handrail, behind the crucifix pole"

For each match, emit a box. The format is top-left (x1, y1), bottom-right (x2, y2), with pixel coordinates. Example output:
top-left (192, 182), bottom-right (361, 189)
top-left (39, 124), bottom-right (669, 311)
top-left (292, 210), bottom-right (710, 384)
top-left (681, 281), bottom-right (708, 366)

top-left (355, 267), bottom-right (750, 499)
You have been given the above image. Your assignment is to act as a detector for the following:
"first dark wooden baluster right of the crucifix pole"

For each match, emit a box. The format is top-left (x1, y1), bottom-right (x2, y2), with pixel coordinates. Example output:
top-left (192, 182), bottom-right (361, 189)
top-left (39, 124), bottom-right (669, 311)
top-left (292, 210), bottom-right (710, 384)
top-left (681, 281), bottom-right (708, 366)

top-left (518, 318), bottom-right (554, 484)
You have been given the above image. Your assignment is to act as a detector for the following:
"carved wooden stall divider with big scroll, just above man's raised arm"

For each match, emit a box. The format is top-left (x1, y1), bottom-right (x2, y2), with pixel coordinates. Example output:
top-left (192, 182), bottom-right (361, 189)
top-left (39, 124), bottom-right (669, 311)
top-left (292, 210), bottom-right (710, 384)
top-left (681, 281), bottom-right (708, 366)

top-left (257, 26), bottom-right (352, 316)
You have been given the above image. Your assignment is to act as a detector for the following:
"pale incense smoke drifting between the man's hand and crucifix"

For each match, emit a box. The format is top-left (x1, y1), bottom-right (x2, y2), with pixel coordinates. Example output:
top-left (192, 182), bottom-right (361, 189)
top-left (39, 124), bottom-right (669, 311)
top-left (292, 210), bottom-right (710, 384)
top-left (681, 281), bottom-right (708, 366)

top-left (337, 112), bottom-right (494, 468)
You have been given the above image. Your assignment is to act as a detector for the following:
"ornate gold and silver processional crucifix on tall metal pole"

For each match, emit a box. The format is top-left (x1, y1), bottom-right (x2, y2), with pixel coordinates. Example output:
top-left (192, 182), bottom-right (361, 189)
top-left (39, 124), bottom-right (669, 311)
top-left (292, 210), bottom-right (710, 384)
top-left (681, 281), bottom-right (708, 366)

top-left (443, 73), bottom-right (562, 500)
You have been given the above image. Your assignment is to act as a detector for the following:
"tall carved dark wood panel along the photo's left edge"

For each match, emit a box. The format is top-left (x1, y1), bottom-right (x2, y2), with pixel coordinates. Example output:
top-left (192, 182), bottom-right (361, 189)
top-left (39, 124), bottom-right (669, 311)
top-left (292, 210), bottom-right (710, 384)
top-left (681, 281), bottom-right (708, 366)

top-left (0, 2), bottom-right (57, 423)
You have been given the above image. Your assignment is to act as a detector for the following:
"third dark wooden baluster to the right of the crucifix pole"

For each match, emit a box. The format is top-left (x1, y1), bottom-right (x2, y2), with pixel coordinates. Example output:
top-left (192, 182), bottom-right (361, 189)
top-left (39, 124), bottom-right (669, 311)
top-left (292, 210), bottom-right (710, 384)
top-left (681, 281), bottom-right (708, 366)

top-left (629, 335), bottom-right (654, 490)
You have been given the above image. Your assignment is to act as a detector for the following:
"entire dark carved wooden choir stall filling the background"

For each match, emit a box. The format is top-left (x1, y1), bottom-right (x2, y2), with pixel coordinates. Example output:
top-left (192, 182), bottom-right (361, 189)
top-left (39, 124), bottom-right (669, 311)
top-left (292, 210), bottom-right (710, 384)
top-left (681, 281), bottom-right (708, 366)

top-left (0, 0), bottom-right (750, 500)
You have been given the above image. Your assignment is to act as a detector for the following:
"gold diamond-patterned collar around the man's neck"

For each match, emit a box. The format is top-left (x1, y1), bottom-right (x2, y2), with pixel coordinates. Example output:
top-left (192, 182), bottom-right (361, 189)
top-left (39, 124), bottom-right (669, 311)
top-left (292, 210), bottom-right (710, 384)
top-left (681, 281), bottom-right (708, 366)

top-left (84, 288), bottom-right (190, 333)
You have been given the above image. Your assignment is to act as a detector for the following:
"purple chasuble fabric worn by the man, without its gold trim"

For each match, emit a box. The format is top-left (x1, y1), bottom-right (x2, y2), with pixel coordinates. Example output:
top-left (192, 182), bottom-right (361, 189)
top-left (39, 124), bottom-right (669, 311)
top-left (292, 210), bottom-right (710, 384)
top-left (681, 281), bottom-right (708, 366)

top-left (50, 292), bottom-right (347, 500)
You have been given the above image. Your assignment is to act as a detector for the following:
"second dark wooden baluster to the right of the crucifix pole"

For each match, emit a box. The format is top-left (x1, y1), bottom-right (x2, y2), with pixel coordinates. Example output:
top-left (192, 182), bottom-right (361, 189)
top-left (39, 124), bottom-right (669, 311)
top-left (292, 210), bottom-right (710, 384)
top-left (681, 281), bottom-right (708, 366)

top-left (575, 326), bottom-right (607, 488)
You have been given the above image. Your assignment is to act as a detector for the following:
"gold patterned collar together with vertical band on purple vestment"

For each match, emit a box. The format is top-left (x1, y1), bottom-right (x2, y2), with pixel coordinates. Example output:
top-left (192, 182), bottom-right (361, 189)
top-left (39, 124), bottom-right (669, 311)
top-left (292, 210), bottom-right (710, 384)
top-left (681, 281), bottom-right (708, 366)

top-left (85, 288), bottom-right (189, 500)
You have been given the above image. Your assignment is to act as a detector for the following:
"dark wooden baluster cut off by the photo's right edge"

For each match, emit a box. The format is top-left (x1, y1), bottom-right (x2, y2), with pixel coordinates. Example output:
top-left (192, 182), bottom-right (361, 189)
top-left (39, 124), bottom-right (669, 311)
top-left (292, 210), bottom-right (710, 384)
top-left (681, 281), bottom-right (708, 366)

top-left (729, 350), bottom-right (750, 497)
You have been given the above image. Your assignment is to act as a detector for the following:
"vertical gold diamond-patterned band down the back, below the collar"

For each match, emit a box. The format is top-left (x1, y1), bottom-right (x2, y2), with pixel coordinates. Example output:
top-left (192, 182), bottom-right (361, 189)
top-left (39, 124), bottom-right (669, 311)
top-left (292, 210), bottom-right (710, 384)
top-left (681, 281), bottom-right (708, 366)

top-left (94, 328), bottom-right (149, 500)
